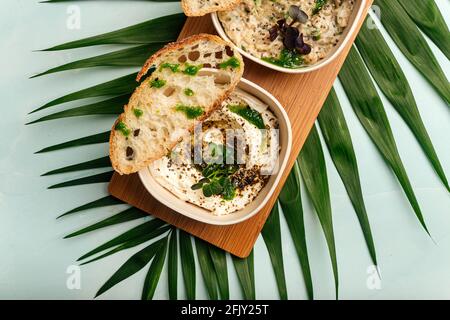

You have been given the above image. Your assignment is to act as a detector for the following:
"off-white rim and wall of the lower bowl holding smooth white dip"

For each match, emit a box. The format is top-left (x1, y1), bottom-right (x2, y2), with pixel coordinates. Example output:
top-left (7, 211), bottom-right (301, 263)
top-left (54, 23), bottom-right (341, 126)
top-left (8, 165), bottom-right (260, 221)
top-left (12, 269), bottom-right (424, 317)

top-left (139, 75), bottom-right (292, 225)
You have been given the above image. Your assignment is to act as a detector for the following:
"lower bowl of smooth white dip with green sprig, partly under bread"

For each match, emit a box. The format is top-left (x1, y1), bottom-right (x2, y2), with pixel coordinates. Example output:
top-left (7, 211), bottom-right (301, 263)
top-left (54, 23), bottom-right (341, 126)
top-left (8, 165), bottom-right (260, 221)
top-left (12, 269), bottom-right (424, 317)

top-left (139, 70), bottom-right (292, 225)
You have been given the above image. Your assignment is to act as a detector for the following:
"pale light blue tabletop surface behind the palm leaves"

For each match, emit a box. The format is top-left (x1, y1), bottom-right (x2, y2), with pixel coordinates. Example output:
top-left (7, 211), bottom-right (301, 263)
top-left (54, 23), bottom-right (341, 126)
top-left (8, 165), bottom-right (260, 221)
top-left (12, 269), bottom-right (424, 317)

top-left (0, 0), bottom-right (450, 299)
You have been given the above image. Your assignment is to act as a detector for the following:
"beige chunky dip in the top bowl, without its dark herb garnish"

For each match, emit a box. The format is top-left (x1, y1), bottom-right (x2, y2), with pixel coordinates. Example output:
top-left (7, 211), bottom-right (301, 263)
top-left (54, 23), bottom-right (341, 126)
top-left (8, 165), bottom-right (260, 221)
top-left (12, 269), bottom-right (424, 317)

top-left (218, 0), bottom-right (355, 65)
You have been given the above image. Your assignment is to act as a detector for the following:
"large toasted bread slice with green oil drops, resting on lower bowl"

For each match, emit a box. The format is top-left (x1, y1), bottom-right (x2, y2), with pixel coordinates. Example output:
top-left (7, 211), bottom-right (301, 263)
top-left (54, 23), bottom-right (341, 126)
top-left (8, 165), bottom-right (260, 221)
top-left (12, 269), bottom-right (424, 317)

top-left (109, 34), bottom-right (244, 174)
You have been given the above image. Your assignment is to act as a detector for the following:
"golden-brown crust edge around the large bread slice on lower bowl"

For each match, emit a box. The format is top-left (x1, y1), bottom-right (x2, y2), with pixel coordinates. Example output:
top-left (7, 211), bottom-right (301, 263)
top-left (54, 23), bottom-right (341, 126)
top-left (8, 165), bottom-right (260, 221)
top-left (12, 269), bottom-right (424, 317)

top-left (109, 34), bottom-right (244, 175)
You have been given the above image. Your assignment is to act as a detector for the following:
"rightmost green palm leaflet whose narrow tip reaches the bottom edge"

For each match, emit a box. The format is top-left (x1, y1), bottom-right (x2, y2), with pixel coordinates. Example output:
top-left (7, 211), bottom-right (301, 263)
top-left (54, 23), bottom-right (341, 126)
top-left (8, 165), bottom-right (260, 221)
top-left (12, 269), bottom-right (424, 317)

top-left (299, 126), bottom-right (339, 299)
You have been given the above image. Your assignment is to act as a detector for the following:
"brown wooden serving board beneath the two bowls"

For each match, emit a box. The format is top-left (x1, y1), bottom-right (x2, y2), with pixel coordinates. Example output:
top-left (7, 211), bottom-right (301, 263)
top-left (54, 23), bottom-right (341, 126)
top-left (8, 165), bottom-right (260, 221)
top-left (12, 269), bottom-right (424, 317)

top-left (109, 1), bottom-right (372, 258)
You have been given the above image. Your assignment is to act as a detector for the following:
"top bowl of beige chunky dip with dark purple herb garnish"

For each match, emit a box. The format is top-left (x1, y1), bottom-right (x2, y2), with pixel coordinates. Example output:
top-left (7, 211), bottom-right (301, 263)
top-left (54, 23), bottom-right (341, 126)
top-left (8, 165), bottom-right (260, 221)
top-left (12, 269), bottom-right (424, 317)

top-left (211, 0), bottom-right (367, 73)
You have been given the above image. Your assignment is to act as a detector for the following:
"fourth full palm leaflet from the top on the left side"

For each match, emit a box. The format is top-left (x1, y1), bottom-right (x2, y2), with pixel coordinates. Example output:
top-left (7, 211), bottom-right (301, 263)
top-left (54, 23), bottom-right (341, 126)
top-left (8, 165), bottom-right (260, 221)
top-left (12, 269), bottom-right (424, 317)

top-left (26, 93), bottom-right (130, 125)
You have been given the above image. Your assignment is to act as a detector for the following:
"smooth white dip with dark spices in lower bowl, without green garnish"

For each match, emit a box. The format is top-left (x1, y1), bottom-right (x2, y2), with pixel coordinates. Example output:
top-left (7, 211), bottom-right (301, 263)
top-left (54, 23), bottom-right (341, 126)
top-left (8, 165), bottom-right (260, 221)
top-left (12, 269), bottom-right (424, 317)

top-left (149, 89), bottom-right (280, 215)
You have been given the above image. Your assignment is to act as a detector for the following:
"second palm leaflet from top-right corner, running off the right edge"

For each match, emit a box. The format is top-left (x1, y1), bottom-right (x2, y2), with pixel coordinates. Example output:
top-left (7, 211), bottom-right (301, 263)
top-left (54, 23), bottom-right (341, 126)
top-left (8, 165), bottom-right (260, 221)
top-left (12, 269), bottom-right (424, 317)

top-left (375, 0), bottom-right (450, 105)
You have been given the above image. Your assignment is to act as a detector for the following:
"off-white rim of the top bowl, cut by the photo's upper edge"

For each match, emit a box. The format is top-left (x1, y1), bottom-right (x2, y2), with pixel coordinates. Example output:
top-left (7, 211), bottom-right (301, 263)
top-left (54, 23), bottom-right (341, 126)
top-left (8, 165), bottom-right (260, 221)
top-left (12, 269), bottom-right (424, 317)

top-left (211, 0), bottom-right (367, 73)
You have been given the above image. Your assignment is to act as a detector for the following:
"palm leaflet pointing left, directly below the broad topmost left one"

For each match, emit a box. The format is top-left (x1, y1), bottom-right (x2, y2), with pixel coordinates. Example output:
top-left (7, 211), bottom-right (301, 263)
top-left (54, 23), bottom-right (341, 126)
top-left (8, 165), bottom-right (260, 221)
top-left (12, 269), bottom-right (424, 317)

top-left (31, 42), bottom-right (167, 78)
